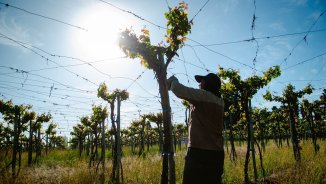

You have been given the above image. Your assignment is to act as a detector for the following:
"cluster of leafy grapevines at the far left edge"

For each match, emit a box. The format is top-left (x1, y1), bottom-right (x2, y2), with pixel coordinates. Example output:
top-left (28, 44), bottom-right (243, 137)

top-left (0, 99), bottom-right (66, 178)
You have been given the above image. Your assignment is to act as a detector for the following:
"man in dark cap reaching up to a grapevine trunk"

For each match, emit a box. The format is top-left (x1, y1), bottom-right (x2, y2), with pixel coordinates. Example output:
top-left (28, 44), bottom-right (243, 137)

top-left (167, 73), bottom-right (224, 184)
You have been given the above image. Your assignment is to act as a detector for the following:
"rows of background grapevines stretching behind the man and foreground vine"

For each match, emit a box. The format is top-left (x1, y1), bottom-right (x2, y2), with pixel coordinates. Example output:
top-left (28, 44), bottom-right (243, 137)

top-left (0, 83), bottom-right (326, 183)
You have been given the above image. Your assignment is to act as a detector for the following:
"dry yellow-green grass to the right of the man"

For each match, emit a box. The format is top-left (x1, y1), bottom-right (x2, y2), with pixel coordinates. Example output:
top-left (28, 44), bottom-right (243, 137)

top-left (223, 141), bottom-right (326, 184)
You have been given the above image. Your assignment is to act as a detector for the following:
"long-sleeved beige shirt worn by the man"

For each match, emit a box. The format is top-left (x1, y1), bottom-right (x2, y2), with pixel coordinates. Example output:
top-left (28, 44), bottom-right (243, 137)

top-left (170, 80), bottom-right (224, 150)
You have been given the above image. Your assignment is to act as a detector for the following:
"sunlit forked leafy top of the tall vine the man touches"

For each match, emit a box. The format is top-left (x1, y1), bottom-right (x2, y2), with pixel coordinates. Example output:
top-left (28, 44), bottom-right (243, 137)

top-left (119, 2), bottom-right (192, 72)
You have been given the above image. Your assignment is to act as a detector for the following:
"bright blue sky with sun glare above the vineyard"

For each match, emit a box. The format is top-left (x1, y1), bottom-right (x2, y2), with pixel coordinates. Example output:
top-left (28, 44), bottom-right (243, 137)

top-left (0, 0), bottom-right (326, 136)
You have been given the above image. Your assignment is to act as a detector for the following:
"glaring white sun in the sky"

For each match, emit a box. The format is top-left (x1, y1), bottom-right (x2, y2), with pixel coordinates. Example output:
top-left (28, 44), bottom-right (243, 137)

top-left (73, 4), bottom-right (130, 59)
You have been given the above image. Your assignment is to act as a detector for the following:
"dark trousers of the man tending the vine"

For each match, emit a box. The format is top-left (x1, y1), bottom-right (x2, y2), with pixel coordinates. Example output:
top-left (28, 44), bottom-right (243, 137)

top-left (182, 148), bottom-right (224, 184)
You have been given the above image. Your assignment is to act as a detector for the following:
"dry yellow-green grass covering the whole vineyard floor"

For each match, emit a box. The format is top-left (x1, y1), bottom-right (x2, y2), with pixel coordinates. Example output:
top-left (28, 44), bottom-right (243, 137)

top-left (0, 141), bottom-right (326, 184)
